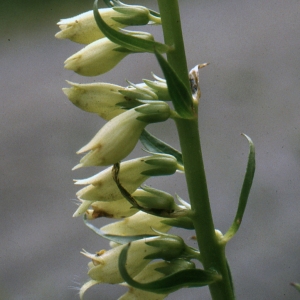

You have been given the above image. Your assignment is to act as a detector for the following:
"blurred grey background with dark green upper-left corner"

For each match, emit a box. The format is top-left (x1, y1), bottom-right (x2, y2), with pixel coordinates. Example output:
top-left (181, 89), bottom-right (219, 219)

top-left (0, 0), bottom-right (300, 300)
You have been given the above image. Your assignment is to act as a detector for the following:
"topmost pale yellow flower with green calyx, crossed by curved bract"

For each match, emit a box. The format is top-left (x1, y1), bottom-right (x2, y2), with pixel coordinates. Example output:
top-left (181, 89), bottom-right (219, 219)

top-left (55, 5), bottom-right (149, 44)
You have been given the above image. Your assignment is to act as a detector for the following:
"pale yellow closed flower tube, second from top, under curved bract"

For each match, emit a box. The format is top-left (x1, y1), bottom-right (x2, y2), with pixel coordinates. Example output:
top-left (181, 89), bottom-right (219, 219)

top-left (65, 37), bottom-right (132, 76)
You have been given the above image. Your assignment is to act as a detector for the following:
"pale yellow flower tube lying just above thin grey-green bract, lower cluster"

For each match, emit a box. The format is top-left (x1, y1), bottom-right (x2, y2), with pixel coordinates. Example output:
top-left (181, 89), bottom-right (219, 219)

top-left (101, 211), bottom-right (171, 236)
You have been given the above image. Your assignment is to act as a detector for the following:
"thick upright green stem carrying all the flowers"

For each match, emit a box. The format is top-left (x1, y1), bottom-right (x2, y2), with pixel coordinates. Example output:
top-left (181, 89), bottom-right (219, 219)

top-left (158, 0), bottom-right (234, 300)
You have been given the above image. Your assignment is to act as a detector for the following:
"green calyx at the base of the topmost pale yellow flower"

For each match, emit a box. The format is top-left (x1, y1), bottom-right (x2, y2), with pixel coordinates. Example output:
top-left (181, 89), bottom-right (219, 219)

top-left (112, 5), bottom-right (149, 26)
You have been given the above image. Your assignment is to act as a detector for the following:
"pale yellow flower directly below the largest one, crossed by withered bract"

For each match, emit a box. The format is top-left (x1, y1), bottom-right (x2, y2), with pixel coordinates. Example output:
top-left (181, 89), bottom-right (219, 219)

top-left (73, 154), bottom-right (177, 217)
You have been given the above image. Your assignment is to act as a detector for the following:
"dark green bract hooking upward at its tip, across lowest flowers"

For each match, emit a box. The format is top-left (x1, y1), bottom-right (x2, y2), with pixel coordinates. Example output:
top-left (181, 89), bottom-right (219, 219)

top-left (119, 244), bottom-right (220, 294)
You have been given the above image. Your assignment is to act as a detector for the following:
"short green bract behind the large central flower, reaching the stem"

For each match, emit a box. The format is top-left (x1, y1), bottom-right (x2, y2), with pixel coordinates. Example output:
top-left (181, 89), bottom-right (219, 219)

top-left (140, 130), bottom-right (183, 167)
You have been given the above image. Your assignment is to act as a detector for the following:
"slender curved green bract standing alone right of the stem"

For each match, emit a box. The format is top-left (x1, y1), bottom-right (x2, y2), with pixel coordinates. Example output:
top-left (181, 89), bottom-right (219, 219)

top-left (222, 134), bottom-right (255, 243)
